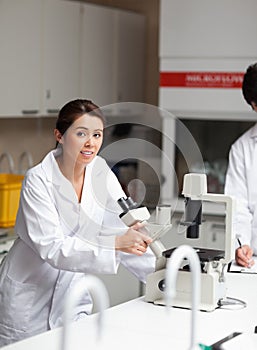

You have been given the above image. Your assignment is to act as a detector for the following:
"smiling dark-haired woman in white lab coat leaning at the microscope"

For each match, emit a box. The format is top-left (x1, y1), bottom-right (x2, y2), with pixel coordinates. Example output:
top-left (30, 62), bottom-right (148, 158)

top-left (0, 99), bottom-right (155, 346)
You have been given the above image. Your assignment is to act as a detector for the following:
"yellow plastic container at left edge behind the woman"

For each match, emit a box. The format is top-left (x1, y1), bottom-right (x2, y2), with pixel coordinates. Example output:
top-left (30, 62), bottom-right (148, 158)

top-left (0, 174), bottom-right (24, 227)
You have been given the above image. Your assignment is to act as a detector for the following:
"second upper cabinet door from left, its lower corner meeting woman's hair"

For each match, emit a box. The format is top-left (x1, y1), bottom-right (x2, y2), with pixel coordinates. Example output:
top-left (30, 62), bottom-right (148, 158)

top-left (42, 0), bottom-right (80, 113)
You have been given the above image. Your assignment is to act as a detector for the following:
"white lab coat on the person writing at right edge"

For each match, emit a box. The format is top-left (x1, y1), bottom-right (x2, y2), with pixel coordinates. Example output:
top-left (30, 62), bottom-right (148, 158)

top-left (225, 124), bottom-right (257, 254)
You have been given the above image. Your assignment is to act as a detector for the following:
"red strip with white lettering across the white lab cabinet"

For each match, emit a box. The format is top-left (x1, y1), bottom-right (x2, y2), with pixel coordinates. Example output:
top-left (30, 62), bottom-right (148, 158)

top-left (160, 72), bottom-right (244, 89)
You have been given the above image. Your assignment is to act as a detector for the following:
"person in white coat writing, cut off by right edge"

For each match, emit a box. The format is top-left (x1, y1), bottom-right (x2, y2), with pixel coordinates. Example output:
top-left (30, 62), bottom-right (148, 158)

top-left (225, 63), bottom-right (257, 267)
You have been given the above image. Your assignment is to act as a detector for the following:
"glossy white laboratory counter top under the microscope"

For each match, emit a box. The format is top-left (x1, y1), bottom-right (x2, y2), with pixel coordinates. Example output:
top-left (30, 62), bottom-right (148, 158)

top-left (2, 273), bottom-right (257, 350)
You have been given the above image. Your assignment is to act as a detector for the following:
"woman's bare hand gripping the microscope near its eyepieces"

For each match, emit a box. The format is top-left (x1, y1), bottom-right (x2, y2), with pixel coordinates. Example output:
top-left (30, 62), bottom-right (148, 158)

top-left (115, 222), bottom-right (152, 256)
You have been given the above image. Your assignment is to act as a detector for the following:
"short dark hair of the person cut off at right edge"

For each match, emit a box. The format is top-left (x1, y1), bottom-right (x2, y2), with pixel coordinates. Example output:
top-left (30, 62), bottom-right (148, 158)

top-left (242, 63), bottom-right (257, 106)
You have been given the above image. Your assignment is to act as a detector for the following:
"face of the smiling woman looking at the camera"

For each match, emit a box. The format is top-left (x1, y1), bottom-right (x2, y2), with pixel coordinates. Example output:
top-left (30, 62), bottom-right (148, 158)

top-left (59, 114), bottom-right (104, 165)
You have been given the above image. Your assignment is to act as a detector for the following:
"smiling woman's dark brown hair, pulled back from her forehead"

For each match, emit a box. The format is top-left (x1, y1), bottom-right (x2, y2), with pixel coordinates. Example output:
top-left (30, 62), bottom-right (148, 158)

top-left (56, 99), bottom-right (105, 135)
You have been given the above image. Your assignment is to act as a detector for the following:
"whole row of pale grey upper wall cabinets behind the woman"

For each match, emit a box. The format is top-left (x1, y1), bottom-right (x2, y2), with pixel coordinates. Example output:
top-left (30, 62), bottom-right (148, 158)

top-left (0, 0), bottom-right (144, 117)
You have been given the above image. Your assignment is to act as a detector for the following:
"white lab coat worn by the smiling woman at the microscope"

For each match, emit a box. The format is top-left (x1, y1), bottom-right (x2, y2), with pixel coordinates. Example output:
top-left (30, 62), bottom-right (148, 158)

top-left (0, 150), bottom-right (155, 346)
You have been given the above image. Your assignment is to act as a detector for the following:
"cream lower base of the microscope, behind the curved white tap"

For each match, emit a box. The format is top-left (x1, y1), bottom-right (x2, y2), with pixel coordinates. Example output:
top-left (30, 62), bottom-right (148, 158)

top-left (145, 269), bottom-right (226, 311)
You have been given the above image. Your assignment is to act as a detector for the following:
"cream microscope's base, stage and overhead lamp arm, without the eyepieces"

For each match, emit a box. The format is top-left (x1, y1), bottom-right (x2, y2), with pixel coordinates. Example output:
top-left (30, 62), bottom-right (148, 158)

top-left (145, 173), bottom-right (235, 311)
